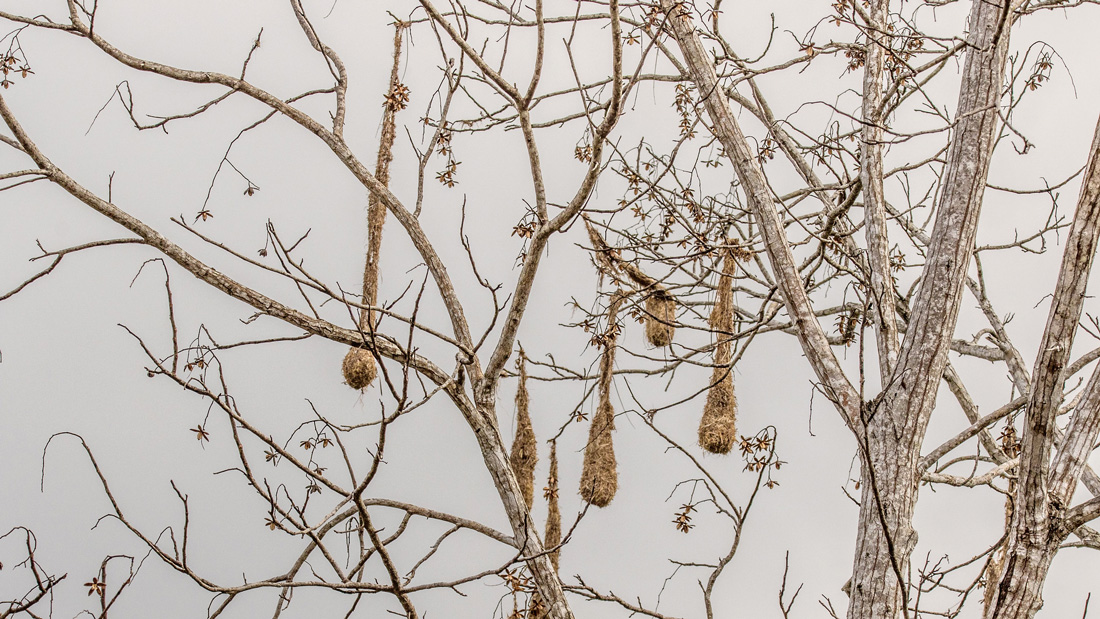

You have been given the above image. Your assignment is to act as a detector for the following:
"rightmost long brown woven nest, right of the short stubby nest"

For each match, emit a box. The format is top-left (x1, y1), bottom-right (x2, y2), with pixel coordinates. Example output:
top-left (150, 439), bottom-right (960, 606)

top-left (699, 252), bottom-right (737, 454)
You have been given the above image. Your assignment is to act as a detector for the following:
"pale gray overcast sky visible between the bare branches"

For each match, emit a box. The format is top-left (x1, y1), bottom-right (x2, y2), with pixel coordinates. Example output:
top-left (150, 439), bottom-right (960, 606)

top-left (0, 0), bottom-right (1100, 618)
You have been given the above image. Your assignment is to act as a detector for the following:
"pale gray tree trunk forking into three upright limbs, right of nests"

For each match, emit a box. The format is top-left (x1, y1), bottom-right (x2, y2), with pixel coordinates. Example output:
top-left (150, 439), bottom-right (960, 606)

top-left (661, 0), bottom-right (1013, 619)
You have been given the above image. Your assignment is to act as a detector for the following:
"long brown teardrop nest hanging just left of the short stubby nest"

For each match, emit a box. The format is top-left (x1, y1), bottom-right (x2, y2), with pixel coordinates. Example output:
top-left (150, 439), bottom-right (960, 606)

top-left (581, 292), bottom-right (626, 507)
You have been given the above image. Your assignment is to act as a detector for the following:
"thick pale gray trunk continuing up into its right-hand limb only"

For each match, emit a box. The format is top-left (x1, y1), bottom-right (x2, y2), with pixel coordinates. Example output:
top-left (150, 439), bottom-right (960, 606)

top-left (848, 0), bottom-right (1012, 619)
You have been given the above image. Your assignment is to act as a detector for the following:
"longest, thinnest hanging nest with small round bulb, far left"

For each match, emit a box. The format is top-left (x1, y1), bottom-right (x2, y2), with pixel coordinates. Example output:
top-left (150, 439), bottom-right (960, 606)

top-left (343, 24), bottom-right (408, 389)
